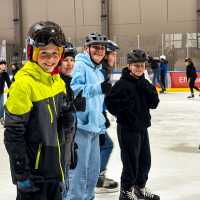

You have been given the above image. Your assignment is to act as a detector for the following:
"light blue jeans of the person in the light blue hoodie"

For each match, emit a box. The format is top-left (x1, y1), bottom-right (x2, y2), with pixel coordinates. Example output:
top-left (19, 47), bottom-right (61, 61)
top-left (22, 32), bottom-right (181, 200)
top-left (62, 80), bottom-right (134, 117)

top-left (65, 129), bottom-right (100, 200)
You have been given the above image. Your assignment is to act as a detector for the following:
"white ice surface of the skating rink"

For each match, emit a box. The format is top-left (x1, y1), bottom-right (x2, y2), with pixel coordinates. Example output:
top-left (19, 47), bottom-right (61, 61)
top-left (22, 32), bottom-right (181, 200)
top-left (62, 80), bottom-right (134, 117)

top-left (0, 93), bottom-right (200, 200)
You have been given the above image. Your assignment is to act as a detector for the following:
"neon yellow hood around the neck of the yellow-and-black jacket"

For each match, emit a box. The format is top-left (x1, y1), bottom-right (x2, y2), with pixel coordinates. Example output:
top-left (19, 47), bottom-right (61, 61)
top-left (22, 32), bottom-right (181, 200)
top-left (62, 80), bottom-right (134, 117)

top-left (15, 61), bottom-right (59, 85)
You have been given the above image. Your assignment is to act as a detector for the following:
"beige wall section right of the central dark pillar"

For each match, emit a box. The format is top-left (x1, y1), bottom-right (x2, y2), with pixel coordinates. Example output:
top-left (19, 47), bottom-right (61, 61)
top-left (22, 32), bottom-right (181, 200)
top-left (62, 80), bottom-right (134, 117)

top-left (110, 0), bottom-right (197, 49)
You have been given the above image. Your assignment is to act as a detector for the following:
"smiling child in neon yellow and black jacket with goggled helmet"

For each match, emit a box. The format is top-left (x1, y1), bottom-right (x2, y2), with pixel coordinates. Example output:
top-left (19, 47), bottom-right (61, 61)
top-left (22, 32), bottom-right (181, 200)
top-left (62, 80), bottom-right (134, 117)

top-left (4, 21), bottom-right (72, 200)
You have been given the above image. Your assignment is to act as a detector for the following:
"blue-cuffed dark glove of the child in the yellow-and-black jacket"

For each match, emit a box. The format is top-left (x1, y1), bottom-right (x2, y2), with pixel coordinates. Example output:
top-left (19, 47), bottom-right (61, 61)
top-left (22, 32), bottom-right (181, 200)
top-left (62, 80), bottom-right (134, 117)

top-left (17, 179), bottom-right (40, 193)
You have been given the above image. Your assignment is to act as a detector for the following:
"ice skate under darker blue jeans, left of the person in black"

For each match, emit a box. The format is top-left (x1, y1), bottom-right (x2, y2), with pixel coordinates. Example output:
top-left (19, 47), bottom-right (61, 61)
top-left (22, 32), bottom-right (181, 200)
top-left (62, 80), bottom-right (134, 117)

top-left (96, 172), bottom-right (119, 194)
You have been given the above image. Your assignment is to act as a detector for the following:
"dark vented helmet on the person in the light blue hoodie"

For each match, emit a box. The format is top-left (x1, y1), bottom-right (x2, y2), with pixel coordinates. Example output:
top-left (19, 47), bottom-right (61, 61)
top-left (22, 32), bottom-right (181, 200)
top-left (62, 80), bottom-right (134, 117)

top-left (85, 32), bottom-right (107, 46)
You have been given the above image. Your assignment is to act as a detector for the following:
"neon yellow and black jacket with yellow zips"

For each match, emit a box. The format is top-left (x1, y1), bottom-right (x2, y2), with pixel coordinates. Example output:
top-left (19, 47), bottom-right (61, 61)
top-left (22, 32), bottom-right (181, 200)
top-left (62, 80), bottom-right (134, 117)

top-left (4, 62), bottom-right (66, 183)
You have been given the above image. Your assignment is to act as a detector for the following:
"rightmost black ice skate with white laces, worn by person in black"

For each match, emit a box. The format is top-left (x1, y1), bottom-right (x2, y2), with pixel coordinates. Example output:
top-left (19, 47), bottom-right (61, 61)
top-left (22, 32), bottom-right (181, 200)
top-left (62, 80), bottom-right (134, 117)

top-left (134, 187), bottom-right (160, 200)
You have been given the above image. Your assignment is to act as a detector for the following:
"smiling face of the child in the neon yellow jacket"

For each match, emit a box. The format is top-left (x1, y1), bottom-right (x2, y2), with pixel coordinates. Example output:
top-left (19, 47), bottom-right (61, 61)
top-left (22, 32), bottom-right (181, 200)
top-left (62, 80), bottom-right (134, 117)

top-left (37, 43), bottom-right (61, 73)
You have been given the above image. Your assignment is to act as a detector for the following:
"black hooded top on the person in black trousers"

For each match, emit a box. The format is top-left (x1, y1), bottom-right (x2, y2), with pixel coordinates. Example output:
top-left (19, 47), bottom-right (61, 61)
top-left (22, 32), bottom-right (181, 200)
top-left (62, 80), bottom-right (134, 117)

top-left (105, 68), bottom-right (159, 130)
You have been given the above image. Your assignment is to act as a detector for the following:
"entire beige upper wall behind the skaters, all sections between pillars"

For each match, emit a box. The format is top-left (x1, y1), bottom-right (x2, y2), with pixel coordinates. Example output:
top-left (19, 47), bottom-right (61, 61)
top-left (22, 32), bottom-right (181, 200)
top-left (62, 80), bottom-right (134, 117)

top-left (0, 0), bottom-right (197, 48)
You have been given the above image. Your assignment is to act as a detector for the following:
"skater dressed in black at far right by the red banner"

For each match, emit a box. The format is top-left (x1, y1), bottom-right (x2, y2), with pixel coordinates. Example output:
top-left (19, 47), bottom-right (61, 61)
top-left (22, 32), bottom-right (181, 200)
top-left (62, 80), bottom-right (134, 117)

top-left (185, 58), bottom-right (200, 98)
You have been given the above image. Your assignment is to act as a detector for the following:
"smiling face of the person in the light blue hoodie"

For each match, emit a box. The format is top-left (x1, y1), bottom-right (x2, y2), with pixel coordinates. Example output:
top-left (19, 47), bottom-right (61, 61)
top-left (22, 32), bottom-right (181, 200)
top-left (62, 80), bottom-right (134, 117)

top-left (86, 44), bottom-right (106, 64)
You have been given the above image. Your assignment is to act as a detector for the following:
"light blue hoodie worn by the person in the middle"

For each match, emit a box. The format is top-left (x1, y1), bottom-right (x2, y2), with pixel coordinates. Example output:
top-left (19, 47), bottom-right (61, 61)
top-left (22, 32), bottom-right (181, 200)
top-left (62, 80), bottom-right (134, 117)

top-left (71, 52), bottom-right (106, 134)
